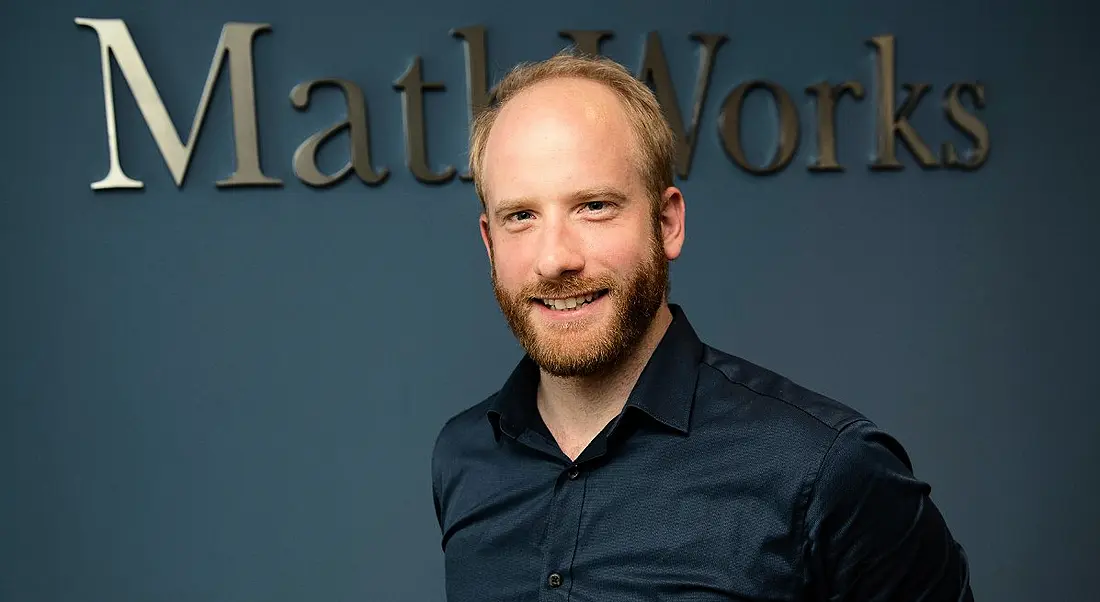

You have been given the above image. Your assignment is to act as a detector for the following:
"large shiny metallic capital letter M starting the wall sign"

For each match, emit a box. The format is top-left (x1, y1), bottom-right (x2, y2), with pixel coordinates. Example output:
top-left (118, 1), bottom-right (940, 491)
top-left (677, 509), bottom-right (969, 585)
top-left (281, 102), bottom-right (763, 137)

top-left (75, 18), bottom-right (282, 190)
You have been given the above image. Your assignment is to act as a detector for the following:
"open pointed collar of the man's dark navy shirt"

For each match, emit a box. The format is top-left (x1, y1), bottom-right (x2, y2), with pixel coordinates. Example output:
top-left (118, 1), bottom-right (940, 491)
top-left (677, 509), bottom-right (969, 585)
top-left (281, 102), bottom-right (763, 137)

top-left (486, 304), bottom-right (703, 439)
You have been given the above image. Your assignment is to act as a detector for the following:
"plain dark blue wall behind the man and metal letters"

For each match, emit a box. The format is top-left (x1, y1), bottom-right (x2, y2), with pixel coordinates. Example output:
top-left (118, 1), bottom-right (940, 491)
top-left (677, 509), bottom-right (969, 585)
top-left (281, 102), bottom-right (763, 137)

top-left (0, 0), bottom-right (1100, 602)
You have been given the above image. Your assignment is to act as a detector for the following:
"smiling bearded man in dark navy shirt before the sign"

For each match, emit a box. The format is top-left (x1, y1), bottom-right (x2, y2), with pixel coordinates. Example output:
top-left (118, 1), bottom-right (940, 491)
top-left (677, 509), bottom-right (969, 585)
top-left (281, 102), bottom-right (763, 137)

top-left (432, 54), bottom-right (972, 602)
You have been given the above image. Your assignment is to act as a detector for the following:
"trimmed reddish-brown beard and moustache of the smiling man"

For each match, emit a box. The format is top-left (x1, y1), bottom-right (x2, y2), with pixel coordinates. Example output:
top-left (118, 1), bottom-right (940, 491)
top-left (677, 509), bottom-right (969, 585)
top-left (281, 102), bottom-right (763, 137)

top-left (493, 230), bottom-right (669, 376)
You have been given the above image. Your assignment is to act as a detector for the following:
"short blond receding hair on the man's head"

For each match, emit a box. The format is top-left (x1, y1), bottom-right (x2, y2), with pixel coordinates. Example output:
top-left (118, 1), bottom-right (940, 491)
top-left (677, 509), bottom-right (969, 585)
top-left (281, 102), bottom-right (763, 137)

top-left (470, 48), bottom-right (677, 214)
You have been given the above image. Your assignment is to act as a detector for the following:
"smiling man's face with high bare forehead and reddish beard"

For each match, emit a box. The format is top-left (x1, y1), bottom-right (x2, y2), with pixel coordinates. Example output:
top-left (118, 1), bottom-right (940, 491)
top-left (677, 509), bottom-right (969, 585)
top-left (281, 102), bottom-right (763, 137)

top-left (481, 79), bottom-right (682, 376)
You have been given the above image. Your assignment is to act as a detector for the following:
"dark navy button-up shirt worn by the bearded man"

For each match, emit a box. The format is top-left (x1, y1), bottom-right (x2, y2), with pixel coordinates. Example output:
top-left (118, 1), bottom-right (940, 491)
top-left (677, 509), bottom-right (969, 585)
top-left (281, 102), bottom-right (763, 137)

top-left (431, 305), bottom-right (972, 602)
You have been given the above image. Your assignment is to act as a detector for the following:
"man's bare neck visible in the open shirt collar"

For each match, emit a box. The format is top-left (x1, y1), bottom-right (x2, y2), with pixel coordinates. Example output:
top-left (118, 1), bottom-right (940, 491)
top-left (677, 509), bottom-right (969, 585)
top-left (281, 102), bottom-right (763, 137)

top-left (538, 304), bottom-right (672, 460)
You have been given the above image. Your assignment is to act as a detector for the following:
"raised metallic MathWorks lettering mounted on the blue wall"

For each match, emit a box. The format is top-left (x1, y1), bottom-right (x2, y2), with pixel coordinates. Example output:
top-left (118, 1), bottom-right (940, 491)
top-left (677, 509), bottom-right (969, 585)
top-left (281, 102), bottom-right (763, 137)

top-left (75, 18), bottom-right (989, 190)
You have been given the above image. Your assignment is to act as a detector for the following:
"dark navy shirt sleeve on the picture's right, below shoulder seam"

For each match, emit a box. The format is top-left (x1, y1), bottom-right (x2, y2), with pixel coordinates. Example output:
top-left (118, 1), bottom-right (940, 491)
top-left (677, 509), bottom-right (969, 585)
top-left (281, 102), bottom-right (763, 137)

top-left (806, 419), bottom-right (974, 602)
